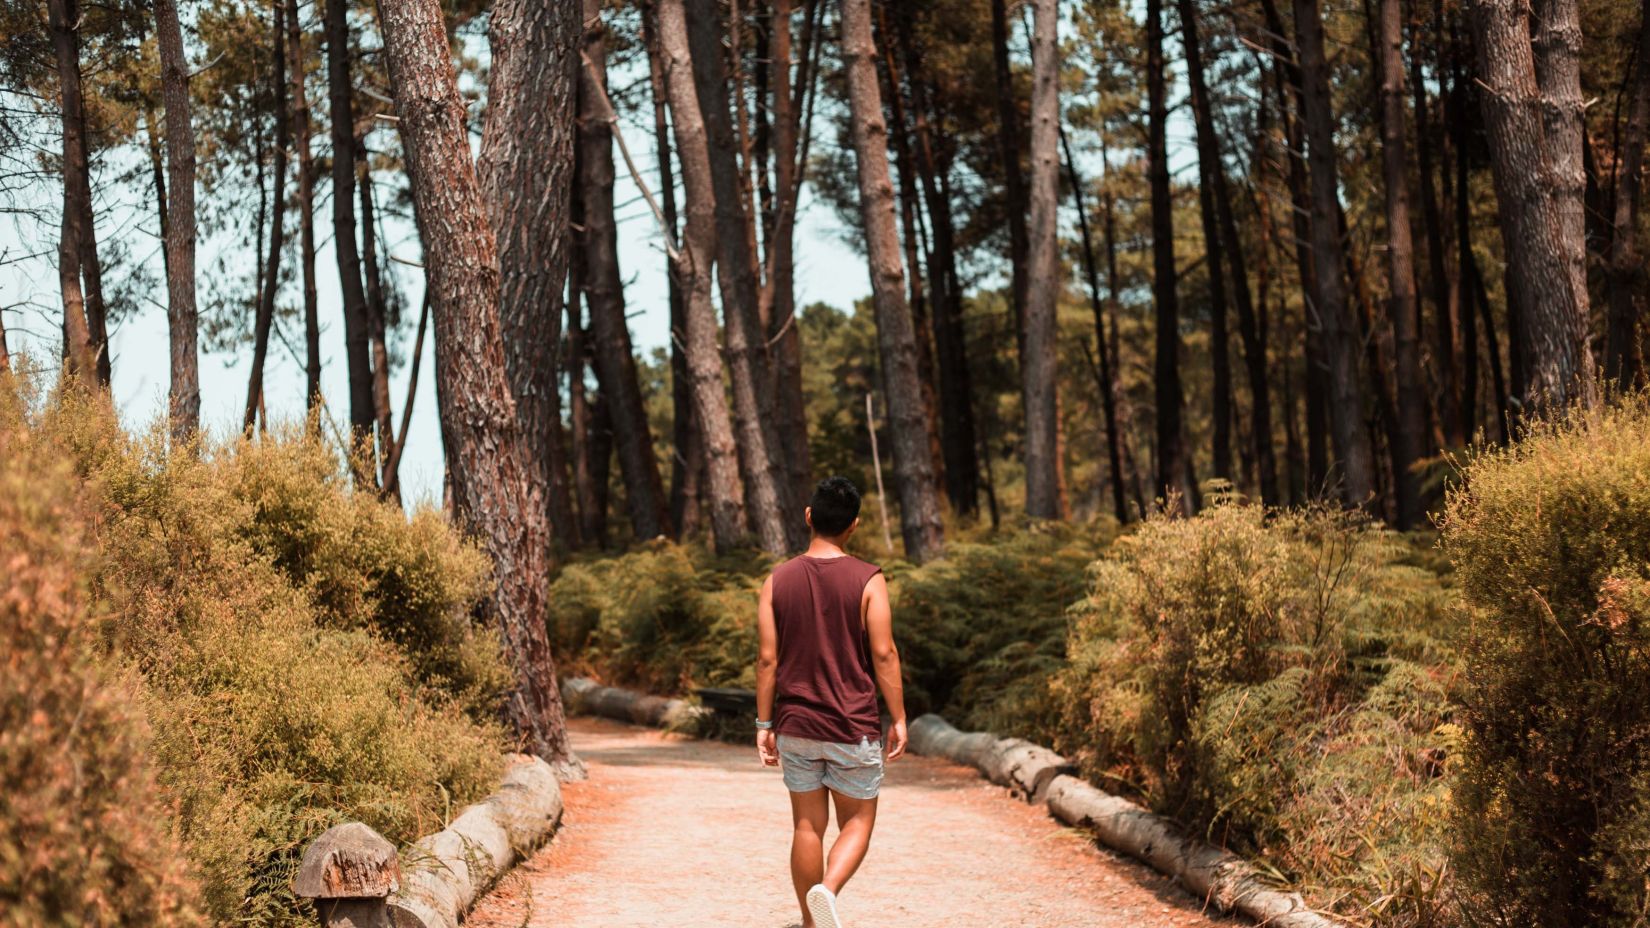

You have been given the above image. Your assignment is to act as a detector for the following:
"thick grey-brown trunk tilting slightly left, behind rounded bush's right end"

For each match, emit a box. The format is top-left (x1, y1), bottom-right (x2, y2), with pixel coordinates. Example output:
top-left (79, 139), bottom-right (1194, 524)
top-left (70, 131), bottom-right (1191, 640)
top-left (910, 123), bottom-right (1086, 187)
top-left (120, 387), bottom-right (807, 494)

top-left (1294, 0), bottom-right (1374, 505)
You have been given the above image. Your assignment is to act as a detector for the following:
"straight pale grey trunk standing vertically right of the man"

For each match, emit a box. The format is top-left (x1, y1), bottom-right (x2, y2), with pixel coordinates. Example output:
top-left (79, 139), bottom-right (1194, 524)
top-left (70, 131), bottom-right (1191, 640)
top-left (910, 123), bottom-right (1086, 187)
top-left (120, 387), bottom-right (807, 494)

top-left (1020, 0), bottom-right (1064, 518)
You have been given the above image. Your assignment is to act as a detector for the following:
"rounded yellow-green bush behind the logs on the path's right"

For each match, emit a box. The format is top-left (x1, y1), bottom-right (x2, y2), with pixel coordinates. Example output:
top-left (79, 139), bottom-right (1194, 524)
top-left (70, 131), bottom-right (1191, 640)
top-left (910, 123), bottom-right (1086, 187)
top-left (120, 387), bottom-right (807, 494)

top-left (1051, 502), bottom-right (1452, 923)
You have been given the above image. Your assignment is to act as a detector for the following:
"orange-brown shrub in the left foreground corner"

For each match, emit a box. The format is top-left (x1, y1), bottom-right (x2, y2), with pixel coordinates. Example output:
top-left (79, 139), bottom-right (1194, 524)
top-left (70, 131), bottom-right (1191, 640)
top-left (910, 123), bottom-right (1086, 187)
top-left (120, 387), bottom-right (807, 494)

top-left (0, 375), bottom-right (200, 926)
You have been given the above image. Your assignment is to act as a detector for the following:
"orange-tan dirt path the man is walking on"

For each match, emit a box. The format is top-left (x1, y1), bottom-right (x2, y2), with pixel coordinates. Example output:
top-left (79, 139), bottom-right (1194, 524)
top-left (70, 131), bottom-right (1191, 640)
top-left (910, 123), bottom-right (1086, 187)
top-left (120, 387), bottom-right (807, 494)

top-left (465, 718), bottom-right (1238, 928)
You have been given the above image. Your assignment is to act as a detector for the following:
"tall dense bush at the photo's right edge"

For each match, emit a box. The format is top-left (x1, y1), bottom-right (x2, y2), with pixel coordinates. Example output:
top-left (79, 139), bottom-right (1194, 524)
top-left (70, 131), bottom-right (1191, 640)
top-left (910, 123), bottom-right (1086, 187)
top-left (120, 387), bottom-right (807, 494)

top-left (1442, 395), bottom-right (1650, 926)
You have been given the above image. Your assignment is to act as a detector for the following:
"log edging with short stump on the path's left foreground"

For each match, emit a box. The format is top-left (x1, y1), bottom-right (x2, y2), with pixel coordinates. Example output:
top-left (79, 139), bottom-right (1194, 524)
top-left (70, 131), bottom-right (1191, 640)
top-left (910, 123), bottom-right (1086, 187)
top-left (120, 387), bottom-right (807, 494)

top-left (292, 755), bottom-right (561, 928)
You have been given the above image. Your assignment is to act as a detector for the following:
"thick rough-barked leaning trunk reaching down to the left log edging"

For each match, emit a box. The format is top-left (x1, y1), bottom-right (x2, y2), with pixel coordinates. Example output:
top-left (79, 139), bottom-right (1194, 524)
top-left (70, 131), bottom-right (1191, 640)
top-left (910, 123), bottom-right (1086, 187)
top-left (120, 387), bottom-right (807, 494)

top-left (378, 0), bottom-right (579, 774)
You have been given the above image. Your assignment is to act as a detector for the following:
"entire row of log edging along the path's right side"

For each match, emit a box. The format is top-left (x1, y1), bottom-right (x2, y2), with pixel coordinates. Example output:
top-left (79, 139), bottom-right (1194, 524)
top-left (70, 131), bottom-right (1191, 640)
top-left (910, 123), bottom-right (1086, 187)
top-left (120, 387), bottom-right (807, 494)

top-left (909, 713), bottom-right (1345, 928)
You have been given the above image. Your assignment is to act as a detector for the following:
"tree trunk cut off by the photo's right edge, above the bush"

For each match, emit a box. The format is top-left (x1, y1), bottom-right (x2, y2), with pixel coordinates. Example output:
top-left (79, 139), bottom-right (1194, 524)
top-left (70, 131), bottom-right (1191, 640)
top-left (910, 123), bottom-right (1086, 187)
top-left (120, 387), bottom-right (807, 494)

top-left (1604, 13), bottom-right (1650, 385)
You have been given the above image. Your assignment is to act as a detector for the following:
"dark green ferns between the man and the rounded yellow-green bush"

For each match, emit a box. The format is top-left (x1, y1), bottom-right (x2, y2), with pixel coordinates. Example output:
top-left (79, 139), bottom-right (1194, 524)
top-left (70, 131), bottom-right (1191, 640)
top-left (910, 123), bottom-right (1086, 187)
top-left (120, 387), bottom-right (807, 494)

top-left (891, 522), bottom-right (1112, 736)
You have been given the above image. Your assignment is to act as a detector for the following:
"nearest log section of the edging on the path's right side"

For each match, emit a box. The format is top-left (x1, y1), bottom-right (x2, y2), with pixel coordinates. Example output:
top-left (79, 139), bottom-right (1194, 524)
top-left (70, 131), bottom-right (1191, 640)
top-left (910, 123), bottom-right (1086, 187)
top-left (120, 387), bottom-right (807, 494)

top-left (1048, 774), bottom-right (1340, 928)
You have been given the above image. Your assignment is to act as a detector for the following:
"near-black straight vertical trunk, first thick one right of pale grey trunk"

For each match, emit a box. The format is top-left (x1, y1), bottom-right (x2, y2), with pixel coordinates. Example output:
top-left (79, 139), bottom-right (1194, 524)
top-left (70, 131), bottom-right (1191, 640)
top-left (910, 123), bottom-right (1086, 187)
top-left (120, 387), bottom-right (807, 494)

top-left (1145, 0), bottom-right (1191, 512)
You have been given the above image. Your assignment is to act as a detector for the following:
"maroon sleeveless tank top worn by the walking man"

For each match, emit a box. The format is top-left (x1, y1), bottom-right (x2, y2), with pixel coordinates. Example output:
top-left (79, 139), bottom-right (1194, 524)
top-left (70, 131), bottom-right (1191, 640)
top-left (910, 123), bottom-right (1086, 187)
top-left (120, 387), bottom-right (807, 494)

top-left (772, 555), bottom-right (883, 745)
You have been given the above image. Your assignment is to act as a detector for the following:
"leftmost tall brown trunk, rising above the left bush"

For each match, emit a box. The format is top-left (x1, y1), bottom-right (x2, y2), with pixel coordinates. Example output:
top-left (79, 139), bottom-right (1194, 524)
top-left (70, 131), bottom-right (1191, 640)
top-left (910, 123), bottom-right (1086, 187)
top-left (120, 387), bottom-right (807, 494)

top-left (46, 0), bottom-right (97, 380)
